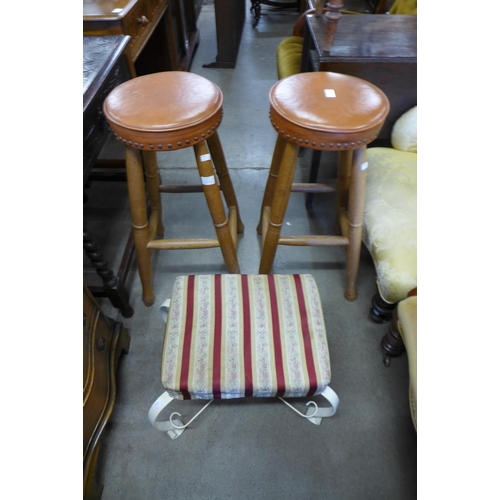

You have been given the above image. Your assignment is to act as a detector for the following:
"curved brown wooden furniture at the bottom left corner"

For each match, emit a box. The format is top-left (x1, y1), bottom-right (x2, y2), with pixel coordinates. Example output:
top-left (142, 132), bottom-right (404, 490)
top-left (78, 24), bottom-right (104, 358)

top-left (83, 284), bottom-right (130, 500)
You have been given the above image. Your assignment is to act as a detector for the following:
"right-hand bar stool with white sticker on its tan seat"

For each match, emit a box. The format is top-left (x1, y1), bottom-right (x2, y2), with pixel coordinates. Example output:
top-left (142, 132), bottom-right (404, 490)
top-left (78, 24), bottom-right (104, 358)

top-left (257, 71), bottom-right (389, 301)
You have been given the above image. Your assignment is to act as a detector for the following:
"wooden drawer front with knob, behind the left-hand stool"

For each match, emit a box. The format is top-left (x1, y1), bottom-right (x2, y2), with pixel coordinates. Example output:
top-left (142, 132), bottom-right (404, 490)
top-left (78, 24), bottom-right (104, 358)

top-left (123, 0), bottom-right (167, 61)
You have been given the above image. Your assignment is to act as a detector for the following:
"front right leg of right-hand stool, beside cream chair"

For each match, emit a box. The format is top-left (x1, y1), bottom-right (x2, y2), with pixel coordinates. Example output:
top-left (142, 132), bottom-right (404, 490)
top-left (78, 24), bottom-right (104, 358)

top-left (344, 146), bottom-right (366, 301)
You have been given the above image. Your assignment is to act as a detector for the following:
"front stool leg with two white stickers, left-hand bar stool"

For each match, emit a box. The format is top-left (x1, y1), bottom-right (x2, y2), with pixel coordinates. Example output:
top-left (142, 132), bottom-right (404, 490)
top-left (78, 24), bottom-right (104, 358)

top-left (193, 141), bottom-right (240, 274)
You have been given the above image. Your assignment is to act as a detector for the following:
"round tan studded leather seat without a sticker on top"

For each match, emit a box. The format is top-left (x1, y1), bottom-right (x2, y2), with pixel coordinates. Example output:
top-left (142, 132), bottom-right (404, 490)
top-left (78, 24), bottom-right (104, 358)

top-left (104, 71), bottom-right (223, 149)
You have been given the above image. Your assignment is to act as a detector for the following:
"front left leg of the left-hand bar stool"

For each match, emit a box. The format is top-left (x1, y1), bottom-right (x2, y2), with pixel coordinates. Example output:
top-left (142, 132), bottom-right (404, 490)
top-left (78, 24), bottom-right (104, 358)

top-left (125, 147), bottom-right (155, 307)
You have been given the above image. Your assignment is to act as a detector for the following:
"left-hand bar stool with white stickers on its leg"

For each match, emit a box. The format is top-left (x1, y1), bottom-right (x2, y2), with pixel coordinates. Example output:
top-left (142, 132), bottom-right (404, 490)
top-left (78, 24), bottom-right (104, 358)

top-left (104, 71), bottom-right (244, 306)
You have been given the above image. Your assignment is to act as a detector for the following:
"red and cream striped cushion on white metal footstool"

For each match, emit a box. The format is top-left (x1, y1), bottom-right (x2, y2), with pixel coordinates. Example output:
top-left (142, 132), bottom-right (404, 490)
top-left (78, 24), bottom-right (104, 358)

top-left (161, 274), bottom-right (331, 399)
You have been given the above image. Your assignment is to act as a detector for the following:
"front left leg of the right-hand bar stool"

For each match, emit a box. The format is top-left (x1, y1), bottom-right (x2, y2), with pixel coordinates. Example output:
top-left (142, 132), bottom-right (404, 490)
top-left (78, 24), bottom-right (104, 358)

top-left (259, 142), bottom-right (299, 274)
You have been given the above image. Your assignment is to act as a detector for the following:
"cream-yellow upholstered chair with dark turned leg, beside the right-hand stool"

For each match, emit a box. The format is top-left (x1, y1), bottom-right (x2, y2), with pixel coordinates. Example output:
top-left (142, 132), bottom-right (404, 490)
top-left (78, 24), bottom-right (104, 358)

top-left (363, 106), bottom-right (417, 322)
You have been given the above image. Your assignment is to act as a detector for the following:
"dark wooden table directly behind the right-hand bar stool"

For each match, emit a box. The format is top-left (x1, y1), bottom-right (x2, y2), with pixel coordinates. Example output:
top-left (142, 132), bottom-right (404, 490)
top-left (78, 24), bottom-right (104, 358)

top-left (302, 14), bottom-right (417, 140)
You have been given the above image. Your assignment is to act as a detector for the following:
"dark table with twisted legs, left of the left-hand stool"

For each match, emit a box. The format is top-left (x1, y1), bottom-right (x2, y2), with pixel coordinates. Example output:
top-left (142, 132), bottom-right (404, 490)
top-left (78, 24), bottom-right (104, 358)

top-left (83, 35), bottom-right (134, 318)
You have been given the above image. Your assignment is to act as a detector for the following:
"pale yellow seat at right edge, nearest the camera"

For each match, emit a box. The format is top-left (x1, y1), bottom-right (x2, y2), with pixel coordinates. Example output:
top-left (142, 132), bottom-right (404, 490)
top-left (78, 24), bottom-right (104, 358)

top-left (398, 296), bottom-right (417, 429)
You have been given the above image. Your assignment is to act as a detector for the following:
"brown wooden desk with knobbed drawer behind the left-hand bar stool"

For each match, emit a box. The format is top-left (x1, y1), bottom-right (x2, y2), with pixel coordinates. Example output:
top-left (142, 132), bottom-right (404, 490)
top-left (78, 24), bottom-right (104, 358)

top-left (83, 0), bottom-right (199, 77)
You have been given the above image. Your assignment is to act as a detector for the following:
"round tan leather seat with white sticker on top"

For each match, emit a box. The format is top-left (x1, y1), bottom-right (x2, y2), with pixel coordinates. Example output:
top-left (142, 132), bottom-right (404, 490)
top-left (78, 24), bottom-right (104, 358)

top-left (269, 71), bottom-right (389, 149)
